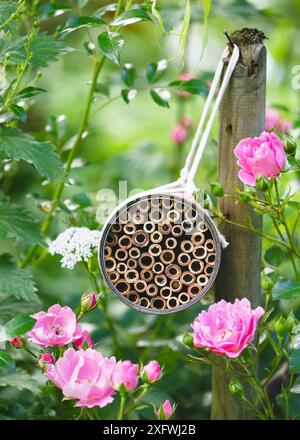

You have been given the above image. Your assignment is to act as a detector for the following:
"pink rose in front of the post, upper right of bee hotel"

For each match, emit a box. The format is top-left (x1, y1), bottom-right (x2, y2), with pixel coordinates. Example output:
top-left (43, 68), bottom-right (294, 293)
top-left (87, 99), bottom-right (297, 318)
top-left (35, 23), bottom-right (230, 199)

top-left (234, 131), bottom-right (286, 186)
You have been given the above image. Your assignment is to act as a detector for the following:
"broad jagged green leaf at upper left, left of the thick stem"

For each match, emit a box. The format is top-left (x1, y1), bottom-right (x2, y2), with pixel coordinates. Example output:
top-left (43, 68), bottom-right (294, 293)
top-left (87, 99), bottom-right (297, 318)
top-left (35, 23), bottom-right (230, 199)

top-left (29, 32), bottom-right (65, 67)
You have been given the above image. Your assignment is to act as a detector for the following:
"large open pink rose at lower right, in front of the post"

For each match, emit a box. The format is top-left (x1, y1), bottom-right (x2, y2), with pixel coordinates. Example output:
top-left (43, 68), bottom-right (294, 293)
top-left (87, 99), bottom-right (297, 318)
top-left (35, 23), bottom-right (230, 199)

top-left (192, 298), bottom-right (265, 358)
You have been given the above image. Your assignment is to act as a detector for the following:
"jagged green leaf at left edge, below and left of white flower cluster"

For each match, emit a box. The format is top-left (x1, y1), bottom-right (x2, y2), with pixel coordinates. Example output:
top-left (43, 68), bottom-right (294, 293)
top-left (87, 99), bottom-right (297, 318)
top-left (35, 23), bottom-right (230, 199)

top-left (0, 255), bottom-right (39, 302)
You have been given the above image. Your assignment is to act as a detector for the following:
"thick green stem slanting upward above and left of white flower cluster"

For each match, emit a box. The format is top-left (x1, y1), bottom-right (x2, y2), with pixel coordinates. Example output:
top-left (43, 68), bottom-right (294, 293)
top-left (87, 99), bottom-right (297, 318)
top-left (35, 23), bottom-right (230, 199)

top-left (21, 56), bottom-right (105, 267)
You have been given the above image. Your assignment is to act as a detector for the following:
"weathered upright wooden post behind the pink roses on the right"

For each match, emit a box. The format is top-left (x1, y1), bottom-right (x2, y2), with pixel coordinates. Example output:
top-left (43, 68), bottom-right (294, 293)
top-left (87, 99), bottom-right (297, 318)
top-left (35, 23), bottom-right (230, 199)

top-left (212, 29), bottom-right (266, 420)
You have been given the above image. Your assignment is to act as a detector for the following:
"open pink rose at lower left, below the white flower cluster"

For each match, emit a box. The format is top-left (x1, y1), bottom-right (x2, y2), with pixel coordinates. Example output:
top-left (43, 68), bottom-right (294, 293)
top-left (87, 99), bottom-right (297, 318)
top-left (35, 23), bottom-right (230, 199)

top-left (27, 304), bottom-right (81, 347)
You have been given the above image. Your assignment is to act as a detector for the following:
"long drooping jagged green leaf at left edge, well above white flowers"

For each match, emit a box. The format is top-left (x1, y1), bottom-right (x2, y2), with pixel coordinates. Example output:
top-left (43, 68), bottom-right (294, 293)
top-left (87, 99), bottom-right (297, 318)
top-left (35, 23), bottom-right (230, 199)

top-left (0, 127), bottom-right (64, 180)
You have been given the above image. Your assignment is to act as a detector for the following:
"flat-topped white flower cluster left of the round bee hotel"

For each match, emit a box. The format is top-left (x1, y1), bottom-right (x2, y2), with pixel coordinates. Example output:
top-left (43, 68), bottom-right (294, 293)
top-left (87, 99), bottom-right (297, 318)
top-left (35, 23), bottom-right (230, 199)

top-left (48, 227), bottom-right (101, 269)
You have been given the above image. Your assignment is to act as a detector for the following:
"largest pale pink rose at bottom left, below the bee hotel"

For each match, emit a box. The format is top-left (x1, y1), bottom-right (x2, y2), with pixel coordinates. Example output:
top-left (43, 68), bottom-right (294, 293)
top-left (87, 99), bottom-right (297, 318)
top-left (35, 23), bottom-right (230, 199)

top-left (45, 348), bottom-right (116, 408)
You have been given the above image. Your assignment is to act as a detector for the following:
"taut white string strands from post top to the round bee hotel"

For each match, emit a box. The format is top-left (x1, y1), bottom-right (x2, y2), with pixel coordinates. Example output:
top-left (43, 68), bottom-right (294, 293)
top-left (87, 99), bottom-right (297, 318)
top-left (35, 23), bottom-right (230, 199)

top-left (180, 45), bottom-right (239, 186)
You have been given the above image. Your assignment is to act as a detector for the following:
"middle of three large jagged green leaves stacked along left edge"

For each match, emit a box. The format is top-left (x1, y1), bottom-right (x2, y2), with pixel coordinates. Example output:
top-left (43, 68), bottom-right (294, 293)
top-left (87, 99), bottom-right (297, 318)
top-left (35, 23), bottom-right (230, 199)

top-left (0, 200), bottom-right (44, 245)
